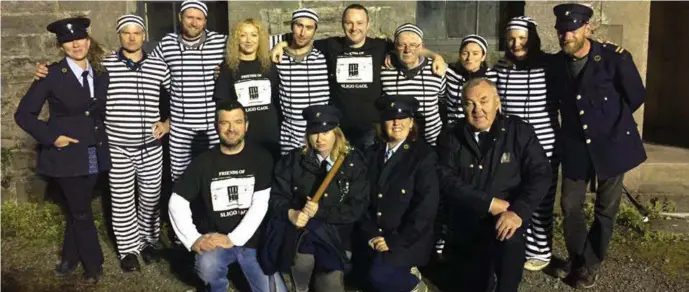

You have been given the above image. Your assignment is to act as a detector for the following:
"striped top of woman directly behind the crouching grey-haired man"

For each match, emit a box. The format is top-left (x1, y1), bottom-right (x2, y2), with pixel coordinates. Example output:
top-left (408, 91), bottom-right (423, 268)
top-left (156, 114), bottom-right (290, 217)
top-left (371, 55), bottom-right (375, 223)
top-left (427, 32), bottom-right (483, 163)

top-left (442, 66), bottom-right (497, 124)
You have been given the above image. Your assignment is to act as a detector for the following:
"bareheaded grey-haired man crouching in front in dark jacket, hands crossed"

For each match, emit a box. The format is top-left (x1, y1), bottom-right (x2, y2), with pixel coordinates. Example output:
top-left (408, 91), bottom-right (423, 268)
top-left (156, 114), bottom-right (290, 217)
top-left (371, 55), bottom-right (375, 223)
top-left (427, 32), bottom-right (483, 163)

top-left (437, 78), bottom-right (552, 291)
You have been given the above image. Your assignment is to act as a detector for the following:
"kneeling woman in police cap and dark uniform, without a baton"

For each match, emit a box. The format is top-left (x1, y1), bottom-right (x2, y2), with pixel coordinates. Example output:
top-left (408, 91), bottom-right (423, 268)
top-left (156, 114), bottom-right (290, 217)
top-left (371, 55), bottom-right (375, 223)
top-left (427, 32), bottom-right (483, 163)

top-left (361, 96), bottom-right (439, 292)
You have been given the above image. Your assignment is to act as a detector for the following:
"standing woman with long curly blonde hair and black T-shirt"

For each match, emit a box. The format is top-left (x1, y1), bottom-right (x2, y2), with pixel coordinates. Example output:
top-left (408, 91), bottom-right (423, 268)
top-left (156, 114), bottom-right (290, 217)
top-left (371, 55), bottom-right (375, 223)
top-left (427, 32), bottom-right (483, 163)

top-left (214, 18), bottom-right (280, 160)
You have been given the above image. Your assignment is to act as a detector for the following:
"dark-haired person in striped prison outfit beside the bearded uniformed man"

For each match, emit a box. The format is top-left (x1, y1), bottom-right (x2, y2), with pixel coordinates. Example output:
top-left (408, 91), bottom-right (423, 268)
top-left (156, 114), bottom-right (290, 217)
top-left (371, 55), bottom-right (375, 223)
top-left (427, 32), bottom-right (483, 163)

top-left (493, 16), bottom-right (560, 271)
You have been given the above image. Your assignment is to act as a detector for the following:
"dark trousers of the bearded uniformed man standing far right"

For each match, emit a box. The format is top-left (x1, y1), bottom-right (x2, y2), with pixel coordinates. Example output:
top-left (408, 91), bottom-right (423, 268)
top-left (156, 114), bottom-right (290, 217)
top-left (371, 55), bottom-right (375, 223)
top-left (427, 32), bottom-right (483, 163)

top-left (560, 174), bottom-right (624, 269)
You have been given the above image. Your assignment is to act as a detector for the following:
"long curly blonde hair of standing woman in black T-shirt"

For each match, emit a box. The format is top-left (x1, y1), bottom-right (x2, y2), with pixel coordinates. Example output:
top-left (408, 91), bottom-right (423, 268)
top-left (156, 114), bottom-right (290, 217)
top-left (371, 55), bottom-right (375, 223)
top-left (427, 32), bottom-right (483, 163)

top-left (225, 18), bottom-right (272, 72)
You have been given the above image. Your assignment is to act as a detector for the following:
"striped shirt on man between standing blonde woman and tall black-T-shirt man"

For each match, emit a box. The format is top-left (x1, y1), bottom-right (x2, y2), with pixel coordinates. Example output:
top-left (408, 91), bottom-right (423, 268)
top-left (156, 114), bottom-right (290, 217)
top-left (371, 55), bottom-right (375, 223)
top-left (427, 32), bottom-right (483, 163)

top-left (276, 48), bottom-right (330, 154)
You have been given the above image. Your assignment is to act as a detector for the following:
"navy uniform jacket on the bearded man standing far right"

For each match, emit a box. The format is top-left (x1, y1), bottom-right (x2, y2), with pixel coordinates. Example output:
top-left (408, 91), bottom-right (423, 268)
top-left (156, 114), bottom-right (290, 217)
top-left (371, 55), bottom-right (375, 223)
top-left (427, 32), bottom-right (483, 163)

top-left (547, 40), bottom-right (646, 179)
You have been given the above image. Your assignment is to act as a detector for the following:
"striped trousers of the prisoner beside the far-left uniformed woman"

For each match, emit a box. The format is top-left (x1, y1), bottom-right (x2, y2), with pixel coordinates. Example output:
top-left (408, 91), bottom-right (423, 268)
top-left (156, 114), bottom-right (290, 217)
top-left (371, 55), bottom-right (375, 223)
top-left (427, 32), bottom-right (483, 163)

top-left (109, 144), bottom-right (163, 258)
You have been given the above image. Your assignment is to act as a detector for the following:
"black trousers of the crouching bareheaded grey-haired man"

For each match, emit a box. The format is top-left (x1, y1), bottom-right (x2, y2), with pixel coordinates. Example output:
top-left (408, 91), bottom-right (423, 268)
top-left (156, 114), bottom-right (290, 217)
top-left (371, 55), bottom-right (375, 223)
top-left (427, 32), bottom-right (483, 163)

top-left (430, 217), bottom-right (530, 292)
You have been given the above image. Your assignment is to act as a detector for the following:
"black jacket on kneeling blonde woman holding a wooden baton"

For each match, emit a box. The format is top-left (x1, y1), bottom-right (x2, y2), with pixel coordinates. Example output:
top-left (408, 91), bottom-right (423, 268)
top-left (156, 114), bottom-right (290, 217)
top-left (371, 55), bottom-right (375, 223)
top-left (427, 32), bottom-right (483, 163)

top-left (270, 147), bottom-right (369, 250)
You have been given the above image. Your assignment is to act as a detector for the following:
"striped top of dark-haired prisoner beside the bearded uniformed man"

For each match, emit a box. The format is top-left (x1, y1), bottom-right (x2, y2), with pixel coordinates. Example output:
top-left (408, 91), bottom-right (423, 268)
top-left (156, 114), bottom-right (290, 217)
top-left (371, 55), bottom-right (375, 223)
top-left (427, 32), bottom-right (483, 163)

top-left (493, 60), bottom-right (560, 157)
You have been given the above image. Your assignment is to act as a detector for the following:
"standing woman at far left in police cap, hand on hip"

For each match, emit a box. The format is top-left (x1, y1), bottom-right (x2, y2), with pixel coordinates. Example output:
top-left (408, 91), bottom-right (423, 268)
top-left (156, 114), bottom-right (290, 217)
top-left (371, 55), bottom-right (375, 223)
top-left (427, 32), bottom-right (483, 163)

top-left (14, 17), bottom-right (110, 284)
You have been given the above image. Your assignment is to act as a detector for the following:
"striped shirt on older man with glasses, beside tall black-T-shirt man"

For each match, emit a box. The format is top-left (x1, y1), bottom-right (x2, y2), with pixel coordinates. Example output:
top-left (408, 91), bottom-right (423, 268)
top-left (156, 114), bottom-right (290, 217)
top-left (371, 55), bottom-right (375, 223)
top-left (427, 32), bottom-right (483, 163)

top-left (380, 58), bottom-right (446, 146)
